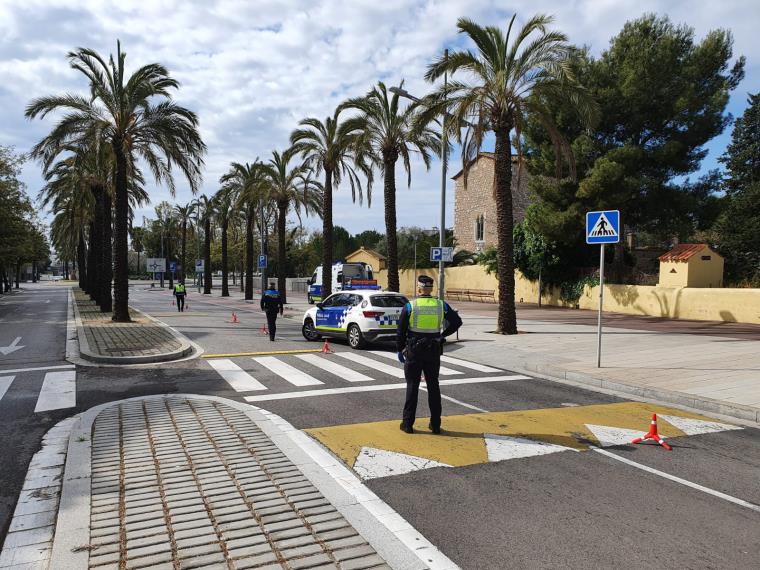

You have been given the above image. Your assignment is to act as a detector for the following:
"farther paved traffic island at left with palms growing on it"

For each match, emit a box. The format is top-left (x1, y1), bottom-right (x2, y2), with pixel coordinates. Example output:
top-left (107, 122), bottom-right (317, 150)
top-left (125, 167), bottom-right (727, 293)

top-left (72, 288), bottom-right (193, 364)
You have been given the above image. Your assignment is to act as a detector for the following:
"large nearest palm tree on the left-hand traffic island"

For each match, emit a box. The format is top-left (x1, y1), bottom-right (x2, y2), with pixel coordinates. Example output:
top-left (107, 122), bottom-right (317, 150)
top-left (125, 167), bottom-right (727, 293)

top-left (26, 42), bottom-right (206, 322)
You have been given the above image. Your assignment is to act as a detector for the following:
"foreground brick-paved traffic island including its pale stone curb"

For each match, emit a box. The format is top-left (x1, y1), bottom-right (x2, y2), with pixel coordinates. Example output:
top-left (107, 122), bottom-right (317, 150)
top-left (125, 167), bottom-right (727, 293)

top-left (41, 394), bottom-right (442, 570)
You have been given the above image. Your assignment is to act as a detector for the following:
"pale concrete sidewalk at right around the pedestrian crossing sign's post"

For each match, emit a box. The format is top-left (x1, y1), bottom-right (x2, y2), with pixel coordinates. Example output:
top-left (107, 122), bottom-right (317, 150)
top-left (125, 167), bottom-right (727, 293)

top-left (447, 307), bottom-right (760, 422)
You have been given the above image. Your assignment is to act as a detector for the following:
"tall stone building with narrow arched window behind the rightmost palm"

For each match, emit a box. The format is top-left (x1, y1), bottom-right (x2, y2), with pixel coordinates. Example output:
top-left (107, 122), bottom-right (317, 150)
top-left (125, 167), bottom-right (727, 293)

top-left (452, 152), bottom-right (530, 252)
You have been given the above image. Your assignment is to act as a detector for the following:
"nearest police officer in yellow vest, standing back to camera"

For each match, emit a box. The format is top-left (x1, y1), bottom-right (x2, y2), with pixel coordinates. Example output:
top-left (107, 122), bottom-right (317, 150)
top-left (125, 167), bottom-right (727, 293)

top-left (396, 275), bottom-right (462, 434)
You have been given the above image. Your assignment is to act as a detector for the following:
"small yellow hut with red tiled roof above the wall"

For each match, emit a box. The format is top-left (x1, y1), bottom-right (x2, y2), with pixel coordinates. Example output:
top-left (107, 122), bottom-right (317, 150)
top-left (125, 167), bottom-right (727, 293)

top-left (658, 243), bottom-right (723, 287)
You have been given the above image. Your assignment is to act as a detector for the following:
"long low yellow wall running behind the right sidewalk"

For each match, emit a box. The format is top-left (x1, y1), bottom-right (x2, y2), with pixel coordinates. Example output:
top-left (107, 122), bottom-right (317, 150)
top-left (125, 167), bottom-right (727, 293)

top-left (377, 265), bottom-right (760, 324)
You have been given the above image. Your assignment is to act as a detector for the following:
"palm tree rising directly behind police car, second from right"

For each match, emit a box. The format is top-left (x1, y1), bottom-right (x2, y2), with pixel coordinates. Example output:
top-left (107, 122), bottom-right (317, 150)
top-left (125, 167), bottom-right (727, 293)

top-left (344, 81), bottom-right (440, 291)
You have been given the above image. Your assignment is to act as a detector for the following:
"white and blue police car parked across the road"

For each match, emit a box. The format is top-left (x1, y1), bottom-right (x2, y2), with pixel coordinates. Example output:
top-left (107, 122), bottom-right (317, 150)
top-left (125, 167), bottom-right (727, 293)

top-left (301, 289), bottom-right (408, 348)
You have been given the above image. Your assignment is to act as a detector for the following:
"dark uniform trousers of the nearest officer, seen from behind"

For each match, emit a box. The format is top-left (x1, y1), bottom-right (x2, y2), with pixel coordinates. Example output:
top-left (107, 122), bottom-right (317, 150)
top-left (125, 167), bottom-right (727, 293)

top-left (404, 333), bottom-right (441, 428)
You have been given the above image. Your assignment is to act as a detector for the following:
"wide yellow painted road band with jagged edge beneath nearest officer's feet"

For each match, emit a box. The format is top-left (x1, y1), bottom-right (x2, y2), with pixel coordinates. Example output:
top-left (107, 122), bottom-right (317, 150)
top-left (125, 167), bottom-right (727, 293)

top-left (305, 402), bottom-right (728, 467)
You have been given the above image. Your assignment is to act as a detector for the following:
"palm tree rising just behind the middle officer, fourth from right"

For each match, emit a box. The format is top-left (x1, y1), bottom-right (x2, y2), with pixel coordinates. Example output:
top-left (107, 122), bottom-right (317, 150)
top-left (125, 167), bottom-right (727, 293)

top-left (262, 148), bottom-right (323, 303)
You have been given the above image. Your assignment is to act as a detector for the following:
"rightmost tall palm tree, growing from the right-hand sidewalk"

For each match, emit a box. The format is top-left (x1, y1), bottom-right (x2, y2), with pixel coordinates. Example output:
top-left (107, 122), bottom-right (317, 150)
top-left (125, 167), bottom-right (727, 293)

top-left (425, 14), bottom-right (596, 334)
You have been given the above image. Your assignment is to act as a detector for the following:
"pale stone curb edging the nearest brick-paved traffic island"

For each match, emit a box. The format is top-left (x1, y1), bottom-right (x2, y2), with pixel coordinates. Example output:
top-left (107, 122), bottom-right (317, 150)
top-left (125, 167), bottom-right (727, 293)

top-left (50, 394), bottom-right (452, 570)
